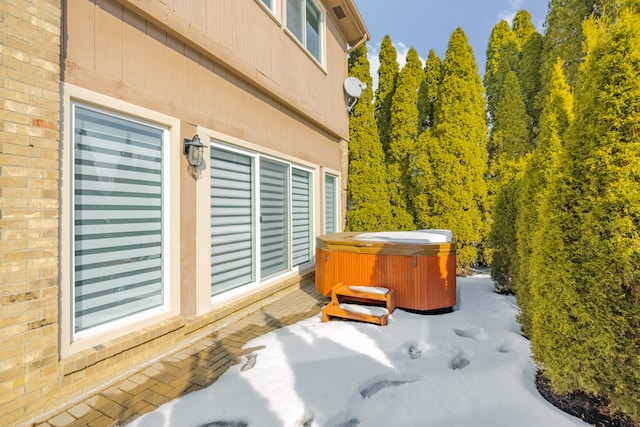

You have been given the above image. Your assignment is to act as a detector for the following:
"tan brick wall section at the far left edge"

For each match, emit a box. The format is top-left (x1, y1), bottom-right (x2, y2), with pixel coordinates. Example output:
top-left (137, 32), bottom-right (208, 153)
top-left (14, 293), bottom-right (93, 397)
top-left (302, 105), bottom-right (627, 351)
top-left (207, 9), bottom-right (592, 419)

top-left (0, 0), bottom-right (61, 426)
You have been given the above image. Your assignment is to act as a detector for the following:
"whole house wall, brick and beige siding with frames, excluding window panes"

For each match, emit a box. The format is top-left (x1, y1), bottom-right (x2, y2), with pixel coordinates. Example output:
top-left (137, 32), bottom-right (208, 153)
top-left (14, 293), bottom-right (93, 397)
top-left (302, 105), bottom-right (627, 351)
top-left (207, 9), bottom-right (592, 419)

top-left (0, 0), bottom-right (368, 426)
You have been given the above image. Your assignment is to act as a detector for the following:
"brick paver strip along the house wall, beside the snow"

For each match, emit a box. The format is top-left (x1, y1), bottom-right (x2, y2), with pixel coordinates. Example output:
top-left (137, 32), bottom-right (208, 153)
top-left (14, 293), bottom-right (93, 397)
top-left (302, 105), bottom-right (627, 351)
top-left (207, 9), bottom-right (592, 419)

top-left (37, 284), bottom-right (328, 427)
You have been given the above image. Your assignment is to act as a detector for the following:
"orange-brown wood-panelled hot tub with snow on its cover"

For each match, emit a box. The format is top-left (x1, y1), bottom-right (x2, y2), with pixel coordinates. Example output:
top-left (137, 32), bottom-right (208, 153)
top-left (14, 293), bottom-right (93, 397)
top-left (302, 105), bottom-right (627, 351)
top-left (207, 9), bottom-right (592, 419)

top-left (315, 230), bottom-right (456, 311)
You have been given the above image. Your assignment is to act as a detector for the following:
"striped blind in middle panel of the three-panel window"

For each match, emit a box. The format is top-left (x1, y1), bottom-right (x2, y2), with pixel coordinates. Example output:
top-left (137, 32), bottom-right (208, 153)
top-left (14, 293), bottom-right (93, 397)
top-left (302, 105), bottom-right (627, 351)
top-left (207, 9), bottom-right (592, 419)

top-left (260, 159), bottom-right (289, 278)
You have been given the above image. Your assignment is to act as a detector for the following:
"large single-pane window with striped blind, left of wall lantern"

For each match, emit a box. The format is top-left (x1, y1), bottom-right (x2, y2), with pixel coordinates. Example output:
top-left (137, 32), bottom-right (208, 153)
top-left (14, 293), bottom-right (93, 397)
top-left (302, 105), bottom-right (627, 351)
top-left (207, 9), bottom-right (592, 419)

top-left (72, 104), bottom-right (167, 333)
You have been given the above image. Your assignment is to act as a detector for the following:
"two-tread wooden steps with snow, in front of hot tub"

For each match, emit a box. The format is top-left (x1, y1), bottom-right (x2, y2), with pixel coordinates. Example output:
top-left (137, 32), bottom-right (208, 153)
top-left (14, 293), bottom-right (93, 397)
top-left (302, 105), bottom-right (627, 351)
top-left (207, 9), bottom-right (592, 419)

top-left (322, 283), bottom-right (396, 326)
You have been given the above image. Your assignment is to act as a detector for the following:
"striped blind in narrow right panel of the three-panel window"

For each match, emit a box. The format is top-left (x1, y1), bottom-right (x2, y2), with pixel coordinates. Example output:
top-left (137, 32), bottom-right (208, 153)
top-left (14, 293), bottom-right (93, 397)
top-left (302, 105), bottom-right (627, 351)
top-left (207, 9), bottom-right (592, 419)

top-left (291, 168), bottom-right (312, 265)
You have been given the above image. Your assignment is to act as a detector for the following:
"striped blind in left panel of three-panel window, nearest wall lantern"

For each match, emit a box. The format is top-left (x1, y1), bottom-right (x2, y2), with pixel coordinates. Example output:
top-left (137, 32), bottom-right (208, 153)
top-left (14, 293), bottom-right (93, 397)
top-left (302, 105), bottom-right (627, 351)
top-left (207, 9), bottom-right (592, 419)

top-left (209, 147), bottom-right (255, 295)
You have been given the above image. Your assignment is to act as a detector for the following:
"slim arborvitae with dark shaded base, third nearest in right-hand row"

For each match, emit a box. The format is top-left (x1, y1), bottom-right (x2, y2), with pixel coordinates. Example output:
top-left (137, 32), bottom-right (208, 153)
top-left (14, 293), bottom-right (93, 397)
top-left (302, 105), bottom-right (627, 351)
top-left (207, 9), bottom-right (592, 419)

top-left (488, 71), bottom-right (533, 292)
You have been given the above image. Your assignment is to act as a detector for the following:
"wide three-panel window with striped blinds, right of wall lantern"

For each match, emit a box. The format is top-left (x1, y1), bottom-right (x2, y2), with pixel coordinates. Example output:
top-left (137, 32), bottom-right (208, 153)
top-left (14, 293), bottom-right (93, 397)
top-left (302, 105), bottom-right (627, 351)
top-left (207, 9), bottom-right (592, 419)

top-left (210, 142), bottom-right (313, 296)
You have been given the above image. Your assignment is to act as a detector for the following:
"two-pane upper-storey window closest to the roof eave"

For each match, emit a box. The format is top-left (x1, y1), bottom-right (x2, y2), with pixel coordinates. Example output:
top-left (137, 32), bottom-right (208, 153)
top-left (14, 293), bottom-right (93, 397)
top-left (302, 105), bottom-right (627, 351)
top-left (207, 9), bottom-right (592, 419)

top-left (287, 0), bottom-right (324, 62)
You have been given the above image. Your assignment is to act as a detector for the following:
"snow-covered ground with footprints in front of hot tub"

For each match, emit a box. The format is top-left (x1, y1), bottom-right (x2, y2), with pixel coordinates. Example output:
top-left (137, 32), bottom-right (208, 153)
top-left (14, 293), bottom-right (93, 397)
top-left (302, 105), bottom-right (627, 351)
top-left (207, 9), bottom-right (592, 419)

top-left (130, 274), bottom-right (587, 427)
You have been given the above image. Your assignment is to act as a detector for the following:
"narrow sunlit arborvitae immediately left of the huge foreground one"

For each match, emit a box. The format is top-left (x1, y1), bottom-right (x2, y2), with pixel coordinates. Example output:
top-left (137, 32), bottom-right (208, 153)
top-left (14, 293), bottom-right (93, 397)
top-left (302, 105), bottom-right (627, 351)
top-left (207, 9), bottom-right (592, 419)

top-left (514, 60), bottom-right (573, 338)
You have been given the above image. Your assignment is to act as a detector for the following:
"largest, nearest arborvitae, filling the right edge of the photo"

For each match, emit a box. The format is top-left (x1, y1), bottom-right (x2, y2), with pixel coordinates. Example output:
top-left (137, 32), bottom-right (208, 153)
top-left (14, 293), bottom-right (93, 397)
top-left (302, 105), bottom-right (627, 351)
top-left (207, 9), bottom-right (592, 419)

top-left (531, 11), bottom-right (640, 422)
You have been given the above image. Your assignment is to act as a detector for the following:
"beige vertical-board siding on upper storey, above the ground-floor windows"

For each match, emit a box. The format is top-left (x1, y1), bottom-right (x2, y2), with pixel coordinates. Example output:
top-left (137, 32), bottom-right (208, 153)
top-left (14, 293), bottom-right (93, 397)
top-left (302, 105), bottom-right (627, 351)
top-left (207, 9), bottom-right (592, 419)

top-left (64, 0), bottom-right (348, 155)
